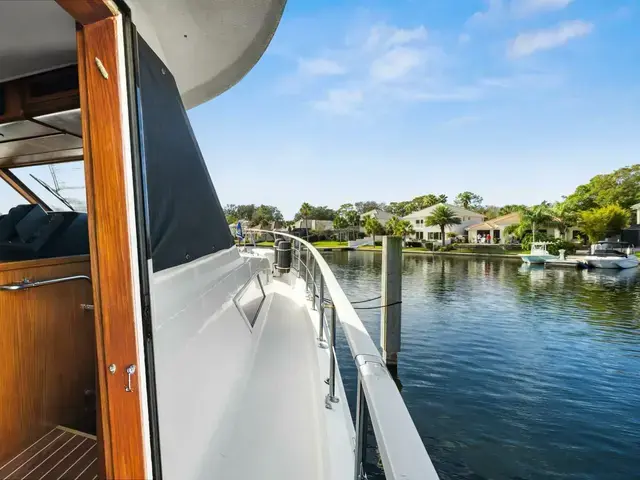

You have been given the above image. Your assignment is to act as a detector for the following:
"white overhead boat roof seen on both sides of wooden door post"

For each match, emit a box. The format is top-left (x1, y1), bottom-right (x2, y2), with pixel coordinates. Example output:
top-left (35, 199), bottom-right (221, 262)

top-left (0, 0), bottom-right (286, 109)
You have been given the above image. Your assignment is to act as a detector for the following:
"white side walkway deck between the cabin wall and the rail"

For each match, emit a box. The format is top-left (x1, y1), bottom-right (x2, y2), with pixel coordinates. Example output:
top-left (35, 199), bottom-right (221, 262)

top-left (210, 281), bottom-right (353, 480)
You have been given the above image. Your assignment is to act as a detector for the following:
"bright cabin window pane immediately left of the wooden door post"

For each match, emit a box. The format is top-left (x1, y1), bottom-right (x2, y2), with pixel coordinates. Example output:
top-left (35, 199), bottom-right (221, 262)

top-left (11, 161), bottom-right (87, 213)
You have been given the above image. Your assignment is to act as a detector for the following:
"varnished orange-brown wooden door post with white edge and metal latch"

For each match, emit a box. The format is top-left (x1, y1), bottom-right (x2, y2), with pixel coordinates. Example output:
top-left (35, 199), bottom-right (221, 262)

top-left (77, 16), bottom-right (151, 479)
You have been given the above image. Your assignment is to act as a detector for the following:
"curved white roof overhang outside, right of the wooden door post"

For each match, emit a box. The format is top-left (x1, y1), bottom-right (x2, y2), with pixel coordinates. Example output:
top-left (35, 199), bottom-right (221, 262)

top-left (125, 0), bottom-right (286, 109)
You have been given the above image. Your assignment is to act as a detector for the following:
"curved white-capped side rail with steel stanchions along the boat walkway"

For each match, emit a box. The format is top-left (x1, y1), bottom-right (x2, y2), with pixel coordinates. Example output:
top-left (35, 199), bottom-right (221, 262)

top-left (252, 229), bottom-right (439, 480)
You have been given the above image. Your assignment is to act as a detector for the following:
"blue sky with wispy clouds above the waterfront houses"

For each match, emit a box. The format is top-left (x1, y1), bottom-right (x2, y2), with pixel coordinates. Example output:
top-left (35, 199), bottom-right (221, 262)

top-left (189, 0), bottom-right (640, 217)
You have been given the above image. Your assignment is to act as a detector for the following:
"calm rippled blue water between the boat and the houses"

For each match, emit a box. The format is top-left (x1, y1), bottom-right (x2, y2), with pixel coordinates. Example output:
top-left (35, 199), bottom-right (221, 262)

top-left (326, 252), bottom-right (640, 479)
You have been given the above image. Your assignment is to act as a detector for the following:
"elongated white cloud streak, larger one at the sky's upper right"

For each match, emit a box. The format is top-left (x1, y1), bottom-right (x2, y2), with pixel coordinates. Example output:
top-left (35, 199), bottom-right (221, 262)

top-left (507, 20), bottom-right (593, 58)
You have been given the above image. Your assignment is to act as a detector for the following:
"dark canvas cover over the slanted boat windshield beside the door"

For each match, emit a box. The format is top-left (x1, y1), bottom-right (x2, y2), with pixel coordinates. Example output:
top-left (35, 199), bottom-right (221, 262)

top-left (138, 36), bottom-right (233, 272)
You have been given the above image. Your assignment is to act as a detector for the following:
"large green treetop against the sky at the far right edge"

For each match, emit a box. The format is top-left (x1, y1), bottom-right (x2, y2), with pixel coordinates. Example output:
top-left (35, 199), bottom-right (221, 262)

top-left (566, 164), bottom-right (640, 211)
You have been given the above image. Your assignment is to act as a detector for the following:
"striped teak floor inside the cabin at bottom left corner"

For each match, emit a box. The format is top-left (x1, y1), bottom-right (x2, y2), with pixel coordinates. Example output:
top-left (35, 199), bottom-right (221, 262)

top-left (0, 427), bottom-right (98, 480)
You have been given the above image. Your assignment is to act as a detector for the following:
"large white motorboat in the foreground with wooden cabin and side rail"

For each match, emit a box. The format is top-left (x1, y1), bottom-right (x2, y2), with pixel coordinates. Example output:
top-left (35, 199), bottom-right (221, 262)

top-left (0, 0), bottom-right (438, 480)
